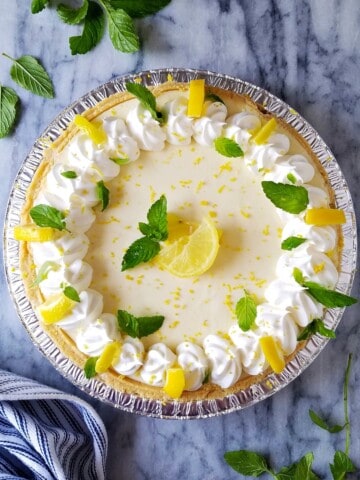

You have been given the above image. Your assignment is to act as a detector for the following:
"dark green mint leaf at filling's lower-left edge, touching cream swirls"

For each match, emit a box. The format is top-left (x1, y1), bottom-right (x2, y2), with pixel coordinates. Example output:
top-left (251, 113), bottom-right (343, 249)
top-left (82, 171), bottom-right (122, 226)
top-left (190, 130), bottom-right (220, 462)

top-left (117, 310), bottom-right (165, 338)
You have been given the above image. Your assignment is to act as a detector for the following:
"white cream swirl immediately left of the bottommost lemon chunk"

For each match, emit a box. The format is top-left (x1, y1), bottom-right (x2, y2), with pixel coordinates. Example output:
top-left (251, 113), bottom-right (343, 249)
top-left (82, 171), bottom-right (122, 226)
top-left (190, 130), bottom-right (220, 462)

top-left (140, 343), bottom-right (176, 387)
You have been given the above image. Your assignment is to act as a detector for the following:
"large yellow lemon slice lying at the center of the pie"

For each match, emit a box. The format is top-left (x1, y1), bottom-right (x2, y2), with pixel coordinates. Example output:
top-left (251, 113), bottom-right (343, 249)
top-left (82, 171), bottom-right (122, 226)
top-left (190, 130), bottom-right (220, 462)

top-left (155, 217), bottom-right (219, 277)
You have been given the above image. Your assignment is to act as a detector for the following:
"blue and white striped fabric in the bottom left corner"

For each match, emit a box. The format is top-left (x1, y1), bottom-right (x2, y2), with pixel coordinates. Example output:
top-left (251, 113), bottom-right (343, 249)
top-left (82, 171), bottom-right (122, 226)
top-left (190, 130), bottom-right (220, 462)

top-left (0, 370), bottom-right (107, 480)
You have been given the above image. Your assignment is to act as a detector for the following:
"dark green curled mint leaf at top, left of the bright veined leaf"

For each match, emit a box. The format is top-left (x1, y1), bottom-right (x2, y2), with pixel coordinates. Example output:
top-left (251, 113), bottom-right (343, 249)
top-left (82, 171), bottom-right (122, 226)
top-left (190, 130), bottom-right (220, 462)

top-left (69, 2), bottom-right (105, 55)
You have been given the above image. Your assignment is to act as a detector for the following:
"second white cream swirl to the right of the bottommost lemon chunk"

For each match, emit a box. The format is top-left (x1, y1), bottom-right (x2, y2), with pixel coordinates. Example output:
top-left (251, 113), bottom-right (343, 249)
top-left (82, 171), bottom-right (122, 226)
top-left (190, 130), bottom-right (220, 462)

top-left (204, 335), bottom-right (241, 388)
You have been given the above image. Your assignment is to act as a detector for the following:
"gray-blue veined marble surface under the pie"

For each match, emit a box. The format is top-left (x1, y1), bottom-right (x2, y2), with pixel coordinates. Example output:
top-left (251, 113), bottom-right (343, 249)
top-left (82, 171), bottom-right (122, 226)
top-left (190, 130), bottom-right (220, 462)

top-left (0, 0), bottom-right (360, 480)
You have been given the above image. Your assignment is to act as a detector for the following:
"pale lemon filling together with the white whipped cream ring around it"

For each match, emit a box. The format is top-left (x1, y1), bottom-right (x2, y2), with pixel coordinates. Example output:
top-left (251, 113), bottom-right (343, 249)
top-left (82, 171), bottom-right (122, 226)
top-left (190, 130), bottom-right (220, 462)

top-left (30, 87), bottom-right (337, 390)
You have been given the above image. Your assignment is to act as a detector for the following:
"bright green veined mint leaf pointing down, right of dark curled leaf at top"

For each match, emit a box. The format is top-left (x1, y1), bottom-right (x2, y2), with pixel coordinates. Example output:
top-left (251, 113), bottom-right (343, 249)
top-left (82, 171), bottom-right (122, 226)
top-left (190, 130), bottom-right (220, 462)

top-left (100, 0), bottom-right (140, 53)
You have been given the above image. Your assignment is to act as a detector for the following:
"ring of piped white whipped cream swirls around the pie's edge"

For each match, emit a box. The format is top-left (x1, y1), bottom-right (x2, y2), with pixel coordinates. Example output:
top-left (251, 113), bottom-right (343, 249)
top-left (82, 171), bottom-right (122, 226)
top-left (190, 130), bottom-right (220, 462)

top-left (30, 88), bottom-right (338, 391)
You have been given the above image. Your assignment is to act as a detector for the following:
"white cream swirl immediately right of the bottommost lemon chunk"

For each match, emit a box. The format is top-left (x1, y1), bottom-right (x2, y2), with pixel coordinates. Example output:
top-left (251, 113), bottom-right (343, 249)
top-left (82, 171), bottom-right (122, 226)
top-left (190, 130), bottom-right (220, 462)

top-left (176, 342), bottom-right (209, 391)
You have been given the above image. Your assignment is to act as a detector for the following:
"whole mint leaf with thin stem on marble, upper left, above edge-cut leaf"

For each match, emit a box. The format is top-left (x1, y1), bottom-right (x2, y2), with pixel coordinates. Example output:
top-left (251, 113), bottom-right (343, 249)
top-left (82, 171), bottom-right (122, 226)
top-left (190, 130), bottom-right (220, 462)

top-left (3, 53), bottom-right (54, 98)
